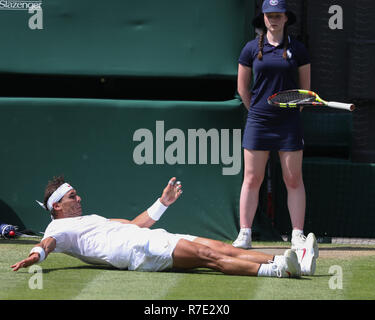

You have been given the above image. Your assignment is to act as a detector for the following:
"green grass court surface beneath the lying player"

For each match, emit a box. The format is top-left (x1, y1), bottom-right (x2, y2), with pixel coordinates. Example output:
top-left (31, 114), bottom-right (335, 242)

top-left (0, 238), bottom-right (375, 300)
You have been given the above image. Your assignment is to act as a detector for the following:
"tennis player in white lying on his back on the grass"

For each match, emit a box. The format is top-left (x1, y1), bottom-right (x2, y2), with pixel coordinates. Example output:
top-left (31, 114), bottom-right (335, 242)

top-left (11, 177), bottom-right (315, 277)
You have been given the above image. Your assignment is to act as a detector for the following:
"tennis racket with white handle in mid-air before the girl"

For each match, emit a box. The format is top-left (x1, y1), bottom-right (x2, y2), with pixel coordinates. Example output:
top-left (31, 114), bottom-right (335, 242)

top-left (267, 89), bottom-right (355, 111)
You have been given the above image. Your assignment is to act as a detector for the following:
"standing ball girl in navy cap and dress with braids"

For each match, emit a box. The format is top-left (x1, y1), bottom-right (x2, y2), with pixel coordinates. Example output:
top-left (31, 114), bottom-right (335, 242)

top-left (233, 0), bottom-right (310, 249)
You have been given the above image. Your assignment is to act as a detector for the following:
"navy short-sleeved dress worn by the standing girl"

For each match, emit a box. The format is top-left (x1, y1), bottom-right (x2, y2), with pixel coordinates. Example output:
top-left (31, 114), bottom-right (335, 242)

top-left (239, 36), bottom-right (310, 151)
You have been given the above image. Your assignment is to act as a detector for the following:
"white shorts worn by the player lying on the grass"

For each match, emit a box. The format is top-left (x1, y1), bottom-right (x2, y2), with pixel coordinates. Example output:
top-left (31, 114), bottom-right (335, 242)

top-left (128, 229), bottom-right (197, 271)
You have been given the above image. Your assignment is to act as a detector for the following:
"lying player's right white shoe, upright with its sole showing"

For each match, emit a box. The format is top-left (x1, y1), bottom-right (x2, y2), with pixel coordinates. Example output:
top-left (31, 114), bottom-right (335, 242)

top-left (295, 233), bottom-right (319, 276)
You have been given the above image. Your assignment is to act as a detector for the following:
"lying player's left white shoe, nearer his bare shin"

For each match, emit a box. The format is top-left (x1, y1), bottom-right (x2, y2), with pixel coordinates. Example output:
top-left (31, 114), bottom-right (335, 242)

top-left (272, 249), bottom-right (301, 278)
